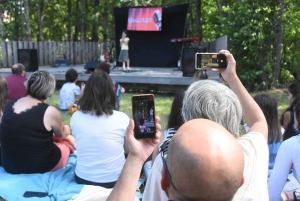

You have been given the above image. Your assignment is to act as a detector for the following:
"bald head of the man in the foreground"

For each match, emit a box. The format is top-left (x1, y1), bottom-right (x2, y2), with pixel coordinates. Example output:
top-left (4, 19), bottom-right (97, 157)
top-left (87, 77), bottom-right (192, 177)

top-left (162, 119), bottom-right (244, 201)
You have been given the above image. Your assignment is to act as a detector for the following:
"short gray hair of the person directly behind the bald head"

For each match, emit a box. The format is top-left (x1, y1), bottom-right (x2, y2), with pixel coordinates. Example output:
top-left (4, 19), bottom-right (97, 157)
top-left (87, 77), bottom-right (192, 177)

top-left (182, 80), bottom-right (242, 137)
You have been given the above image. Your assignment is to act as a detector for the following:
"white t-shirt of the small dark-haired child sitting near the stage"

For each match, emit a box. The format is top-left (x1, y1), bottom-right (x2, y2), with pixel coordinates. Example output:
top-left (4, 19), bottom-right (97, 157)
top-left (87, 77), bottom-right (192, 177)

top-left (59, 82), bottom-right (81, 110)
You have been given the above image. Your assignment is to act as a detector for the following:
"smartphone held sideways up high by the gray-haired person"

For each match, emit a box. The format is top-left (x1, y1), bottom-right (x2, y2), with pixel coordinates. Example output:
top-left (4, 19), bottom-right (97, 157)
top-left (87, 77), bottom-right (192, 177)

top-left (195, 53), bottom-right (227, 69)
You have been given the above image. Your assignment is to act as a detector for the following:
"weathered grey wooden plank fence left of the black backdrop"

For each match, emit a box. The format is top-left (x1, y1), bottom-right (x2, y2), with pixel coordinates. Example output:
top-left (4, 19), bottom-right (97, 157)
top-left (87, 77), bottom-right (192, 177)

top-left (0, 41), bottom-right (103, 67)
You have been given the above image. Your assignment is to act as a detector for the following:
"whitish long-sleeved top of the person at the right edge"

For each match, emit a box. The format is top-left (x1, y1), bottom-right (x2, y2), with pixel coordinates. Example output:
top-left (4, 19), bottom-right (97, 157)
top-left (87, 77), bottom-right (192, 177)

top-left (268, 135), bottom-right (300, 201)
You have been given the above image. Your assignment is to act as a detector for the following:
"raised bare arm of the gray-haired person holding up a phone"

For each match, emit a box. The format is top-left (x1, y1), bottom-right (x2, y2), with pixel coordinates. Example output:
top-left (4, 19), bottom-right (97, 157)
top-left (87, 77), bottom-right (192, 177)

top-left (216, 50), bottom-right (268, 141)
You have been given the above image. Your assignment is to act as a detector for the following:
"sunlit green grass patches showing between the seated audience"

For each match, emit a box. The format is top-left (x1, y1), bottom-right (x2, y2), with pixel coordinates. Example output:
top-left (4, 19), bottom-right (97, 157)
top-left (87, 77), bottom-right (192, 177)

top-left (46, 90), bottom-right (289, 131)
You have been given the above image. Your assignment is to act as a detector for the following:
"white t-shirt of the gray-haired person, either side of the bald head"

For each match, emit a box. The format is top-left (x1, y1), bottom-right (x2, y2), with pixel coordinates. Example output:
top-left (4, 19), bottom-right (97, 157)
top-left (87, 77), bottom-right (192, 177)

top-left (143, 132), bottom-right (269, 201)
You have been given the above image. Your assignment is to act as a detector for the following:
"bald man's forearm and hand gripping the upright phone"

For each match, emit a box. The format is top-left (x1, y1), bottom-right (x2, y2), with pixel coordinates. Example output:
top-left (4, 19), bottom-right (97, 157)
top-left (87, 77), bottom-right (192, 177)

top-left (107, 118), bottom-right (160, 201)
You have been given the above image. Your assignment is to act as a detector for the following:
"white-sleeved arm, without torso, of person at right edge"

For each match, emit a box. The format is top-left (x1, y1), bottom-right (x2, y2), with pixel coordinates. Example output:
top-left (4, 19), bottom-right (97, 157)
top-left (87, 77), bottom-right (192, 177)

top-left (268, 139), bottom-right (294, 201)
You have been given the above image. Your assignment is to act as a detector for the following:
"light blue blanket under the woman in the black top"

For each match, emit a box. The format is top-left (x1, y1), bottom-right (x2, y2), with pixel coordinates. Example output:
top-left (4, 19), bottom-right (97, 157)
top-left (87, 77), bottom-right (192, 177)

top-left (0, 154), bottom-right (84, 201)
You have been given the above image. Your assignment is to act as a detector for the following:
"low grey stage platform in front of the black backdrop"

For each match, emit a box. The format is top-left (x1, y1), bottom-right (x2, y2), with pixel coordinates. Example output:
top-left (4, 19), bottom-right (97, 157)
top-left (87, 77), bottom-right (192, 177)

top-left (0, 65), bottom-right (219, 92)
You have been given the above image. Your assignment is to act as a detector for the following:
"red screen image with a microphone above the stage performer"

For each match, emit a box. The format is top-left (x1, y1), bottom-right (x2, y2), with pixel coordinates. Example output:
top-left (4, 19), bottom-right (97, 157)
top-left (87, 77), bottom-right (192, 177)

top-left (127, 7), bottom-right (162, 31)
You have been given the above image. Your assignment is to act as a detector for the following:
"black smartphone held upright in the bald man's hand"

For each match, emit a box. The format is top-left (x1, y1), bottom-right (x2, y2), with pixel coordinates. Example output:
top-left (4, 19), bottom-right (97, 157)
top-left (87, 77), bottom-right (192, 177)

top-left (131, 94), bottom-right (156, 139)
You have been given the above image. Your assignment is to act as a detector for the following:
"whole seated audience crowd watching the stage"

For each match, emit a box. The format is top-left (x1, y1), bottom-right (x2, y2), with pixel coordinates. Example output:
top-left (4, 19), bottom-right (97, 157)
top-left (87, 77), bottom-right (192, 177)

top-left (0, 50), bottom-right (300, 201)
